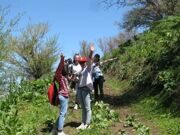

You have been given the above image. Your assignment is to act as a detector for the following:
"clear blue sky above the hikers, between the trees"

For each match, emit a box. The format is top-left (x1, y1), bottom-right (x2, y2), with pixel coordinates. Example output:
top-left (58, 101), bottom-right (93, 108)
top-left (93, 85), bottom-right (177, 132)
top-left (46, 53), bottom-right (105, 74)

top-left (0, 0), bottom-right (131, 57)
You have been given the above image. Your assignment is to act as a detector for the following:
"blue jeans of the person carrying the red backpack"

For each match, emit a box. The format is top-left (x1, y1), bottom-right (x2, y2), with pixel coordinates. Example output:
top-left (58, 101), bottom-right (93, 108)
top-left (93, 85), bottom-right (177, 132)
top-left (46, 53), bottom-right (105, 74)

top-left (56, 94), bottom-right (69, 130)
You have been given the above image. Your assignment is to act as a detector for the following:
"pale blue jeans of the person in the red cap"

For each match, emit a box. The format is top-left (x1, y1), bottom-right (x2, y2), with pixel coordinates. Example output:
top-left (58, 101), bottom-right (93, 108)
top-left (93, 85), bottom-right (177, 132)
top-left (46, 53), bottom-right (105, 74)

top-left (79, 87), bottom-right (92, 124)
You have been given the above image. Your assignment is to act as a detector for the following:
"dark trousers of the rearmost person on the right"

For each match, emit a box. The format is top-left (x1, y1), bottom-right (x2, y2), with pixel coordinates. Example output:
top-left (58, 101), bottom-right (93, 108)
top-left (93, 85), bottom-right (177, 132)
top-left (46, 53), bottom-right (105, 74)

top-left (93, 76), bottom-right (104, 100)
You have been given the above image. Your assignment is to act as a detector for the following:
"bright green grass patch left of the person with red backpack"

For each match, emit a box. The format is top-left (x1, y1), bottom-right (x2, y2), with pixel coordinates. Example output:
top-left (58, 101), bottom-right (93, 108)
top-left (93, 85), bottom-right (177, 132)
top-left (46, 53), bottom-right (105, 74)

top-left (18, 96), bottom-right (58, 135)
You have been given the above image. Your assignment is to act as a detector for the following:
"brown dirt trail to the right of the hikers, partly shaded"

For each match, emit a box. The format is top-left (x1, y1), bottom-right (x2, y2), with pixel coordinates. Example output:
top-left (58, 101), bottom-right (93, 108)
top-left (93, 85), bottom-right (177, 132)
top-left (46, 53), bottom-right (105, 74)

top-left (104, 85), bottom-right (159, 135)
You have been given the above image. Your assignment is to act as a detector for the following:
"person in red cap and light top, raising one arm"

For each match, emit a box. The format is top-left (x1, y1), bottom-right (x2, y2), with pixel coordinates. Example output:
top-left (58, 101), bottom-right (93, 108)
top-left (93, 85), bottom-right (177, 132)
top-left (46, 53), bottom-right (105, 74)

top-left (77, 45), bottom-right (94, 129)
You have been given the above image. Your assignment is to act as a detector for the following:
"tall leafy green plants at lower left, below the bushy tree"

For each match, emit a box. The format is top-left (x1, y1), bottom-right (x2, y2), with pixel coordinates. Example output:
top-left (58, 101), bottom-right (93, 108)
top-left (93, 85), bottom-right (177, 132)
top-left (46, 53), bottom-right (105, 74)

top-left (0, 78), bottom-right (51, 135)
